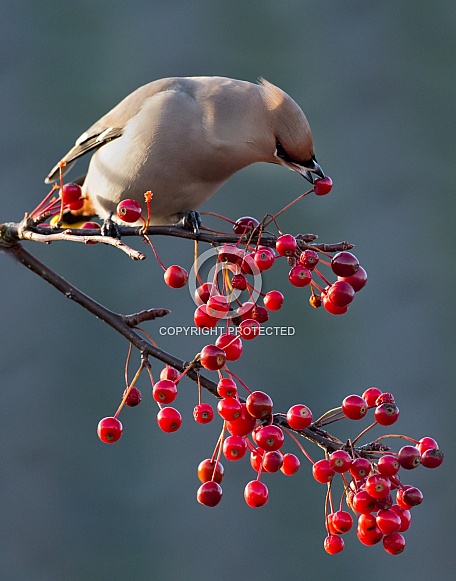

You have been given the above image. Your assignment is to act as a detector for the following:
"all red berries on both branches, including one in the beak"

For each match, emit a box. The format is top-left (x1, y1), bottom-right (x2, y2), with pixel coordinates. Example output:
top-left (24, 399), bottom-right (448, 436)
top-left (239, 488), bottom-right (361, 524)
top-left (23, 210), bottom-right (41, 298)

top-left (24, 178), bottom-right (443, 555)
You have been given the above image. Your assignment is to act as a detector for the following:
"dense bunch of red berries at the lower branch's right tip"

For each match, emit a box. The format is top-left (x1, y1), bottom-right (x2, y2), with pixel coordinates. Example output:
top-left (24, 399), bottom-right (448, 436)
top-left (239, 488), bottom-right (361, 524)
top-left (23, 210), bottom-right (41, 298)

top-left (312, 387), bottom-right (443, 555)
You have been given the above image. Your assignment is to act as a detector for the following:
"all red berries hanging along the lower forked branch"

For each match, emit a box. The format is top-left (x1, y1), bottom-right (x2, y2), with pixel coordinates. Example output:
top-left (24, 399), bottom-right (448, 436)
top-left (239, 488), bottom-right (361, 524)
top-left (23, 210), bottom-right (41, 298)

top-left (98, 358), bottom-right (443, 555)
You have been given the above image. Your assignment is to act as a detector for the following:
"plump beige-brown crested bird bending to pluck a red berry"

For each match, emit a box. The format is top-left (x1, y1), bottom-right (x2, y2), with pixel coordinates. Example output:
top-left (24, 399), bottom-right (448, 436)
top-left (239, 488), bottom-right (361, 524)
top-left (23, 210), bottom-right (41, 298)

top-left (45, 76), bottom-right (325, 225)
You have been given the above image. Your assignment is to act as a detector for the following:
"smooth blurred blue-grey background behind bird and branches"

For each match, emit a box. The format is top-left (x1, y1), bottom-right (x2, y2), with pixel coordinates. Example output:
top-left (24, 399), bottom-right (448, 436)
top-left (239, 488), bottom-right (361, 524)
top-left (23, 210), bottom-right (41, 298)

top-left (0, 0), bottom-right (456, 581)
